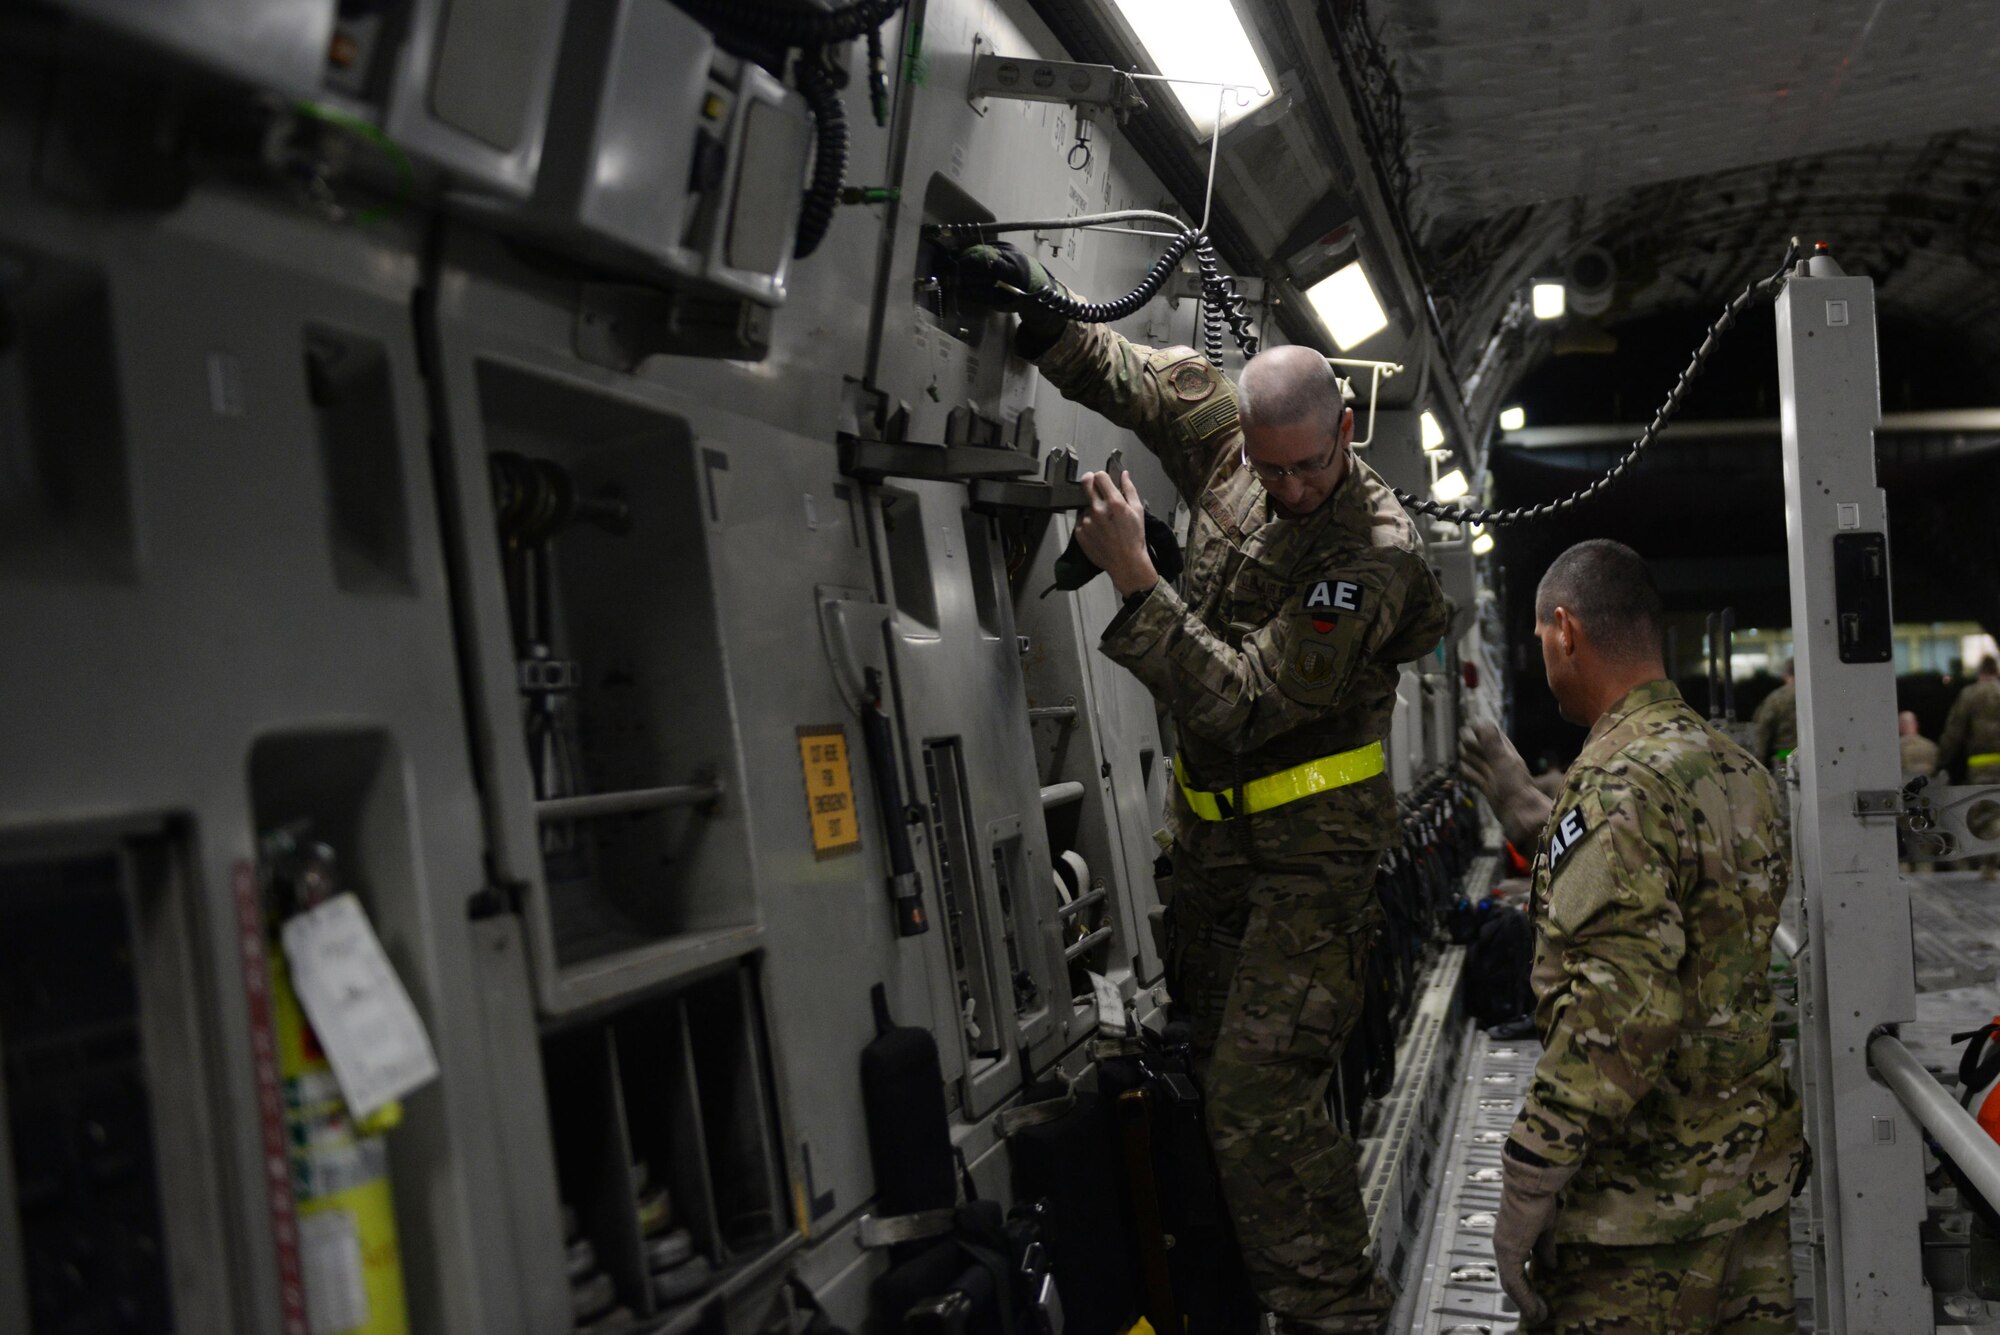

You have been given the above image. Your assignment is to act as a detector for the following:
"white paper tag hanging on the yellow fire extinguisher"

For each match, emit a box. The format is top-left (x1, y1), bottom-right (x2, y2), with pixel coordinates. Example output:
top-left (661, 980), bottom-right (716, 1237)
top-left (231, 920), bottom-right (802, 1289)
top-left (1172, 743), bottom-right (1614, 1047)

top-left (282, 893), bottom-right (438, 1119)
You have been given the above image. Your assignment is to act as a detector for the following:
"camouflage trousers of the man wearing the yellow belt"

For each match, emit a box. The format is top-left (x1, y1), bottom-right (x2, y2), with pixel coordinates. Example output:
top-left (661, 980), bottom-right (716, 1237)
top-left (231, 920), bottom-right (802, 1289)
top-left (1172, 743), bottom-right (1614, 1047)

top-left (1168, 853), bottom-right (1396, 1335)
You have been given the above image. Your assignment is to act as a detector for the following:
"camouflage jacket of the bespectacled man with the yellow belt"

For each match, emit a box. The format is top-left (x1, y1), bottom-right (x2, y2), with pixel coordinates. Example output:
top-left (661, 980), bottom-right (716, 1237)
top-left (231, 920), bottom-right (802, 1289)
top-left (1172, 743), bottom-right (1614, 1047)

top-left (1036, 324), bottom-right (1450, 867)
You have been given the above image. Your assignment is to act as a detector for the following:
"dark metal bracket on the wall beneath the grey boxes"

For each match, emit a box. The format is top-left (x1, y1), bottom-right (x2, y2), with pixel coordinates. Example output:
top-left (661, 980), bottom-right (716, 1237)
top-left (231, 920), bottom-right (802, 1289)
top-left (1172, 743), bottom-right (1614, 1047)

top-left (574, 282), bottom-right (770, 372)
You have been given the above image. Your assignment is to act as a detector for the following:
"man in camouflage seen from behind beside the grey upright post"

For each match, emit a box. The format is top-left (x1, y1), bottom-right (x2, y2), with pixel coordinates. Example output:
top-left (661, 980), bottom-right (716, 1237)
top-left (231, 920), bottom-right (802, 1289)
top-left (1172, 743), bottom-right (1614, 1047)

top-left (1494, 540), bottom-right (1804, 1335)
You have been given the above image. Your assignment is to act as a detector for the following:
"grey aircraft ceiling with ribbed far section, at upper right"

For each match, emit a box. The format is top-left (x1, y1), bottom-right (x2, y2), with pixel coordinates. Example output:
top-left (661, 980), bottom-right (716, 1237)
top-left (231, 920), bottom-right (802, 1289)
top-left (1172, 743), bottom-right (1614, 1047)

top-left (1336, 0), bottom-right (2000, 364)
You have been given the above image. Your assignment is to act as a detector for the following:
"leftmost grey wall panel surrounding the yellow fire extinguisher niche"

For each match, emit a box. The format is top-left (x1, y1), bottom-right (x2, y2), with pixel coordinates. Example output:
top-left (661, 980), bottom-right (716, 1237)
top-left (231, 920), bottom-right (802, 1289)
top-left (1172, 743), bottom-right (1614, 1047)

top-left (0, 182), bottom-right (534, 1331)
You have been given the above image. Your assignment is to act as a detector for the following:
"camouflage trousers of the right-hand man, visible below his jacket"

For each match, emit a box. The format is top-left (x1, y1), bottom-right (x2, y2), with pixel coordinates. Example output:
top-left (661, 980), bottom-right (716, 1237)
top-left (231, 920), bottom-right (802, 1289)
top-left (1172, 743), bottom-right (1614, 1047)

top-left (1530, 1209), bottom-right (1798, 1335)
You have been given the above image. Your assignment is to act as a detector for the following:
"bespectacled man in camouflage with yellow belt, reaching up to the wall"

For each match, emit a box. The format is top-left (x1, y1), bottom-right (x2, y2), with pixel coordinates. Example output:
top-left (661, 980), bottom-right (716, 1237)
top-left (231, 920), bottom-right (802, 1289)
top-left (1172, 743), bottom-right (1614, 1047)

top-left (952, 248), bottom-right (1450, 1333)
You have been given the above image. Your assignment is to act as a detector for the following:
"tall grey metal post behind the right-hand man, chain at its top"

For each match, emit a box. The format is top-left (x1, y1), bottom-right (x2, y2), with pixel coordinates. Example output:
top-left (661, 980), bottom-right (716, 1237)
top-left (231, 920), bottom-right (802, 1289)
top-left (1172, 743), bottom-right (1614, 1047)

top-left (1778, 246), bottom-right (1934, 1335)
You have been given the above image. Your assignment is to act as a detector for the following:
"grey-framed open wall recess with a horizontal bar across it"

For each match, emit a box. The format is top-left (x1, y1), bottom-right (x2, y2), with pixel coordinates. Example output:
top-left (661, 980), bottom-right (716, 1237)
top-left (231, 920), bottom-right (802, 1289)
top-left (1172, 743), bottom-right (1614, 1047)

top-left (422, 230), bottom-right (760, 1013)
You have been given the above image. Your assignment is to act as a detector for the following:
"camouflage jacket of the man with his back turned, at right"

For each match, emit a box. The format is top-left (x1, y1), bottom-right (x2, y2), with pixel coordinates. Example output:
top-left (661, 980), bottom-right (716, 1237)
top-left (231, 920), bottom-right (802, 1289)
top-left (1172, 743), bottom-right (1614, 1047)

top-left (1512, 681), bottom-right (1804, 1245)
